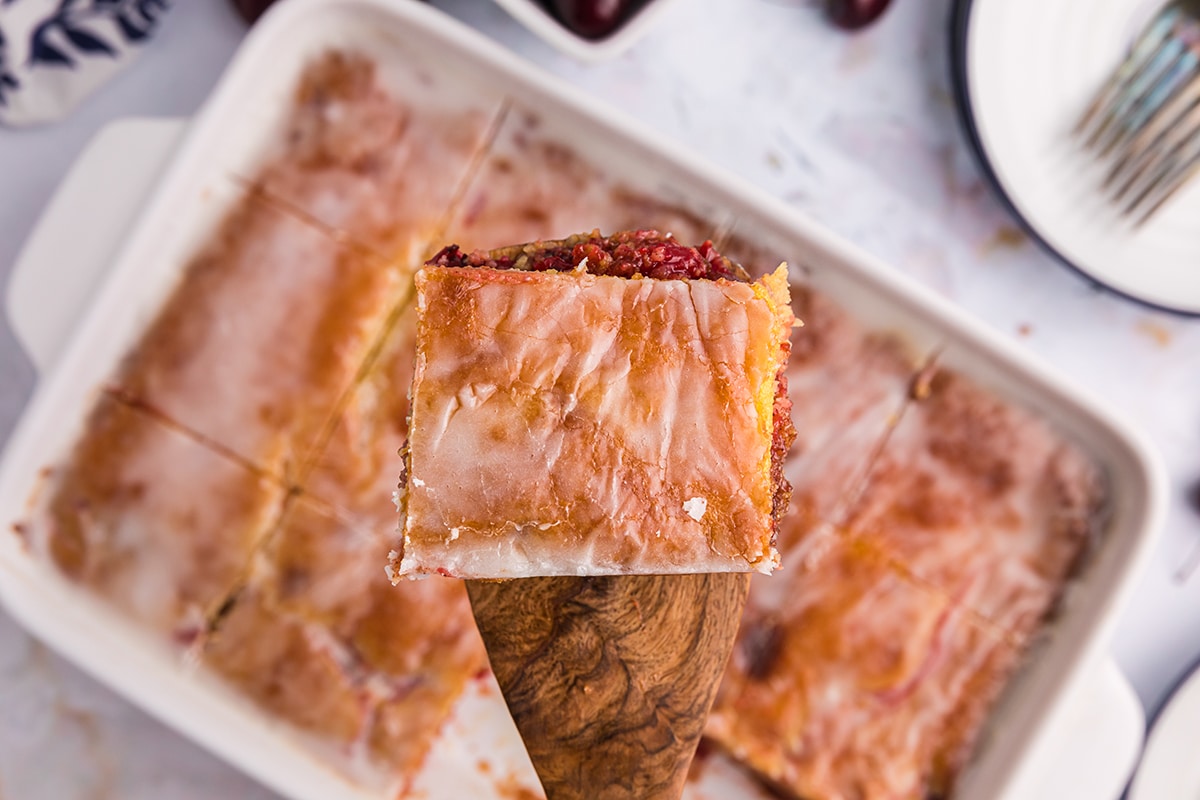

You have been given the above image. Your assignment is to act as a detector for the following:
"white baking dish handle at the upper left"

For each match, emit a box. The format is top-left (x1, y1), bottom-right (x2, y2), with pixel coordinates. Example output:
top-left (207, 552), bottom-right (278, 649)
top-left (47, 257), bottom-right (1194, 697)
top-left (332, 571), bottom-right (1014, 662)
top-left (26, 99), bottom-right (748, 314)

top-left (7, 119), bottom-right (186, 373)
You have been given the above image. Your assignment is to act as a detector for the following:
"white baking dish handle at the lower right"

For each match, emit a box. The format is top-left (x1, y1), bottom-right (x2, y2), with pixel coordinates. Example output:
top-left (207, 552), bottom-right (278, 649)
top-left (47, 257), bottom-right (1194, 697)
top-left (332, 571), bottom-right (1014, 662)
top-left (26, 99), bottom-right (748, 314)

top-left (1004, 656), bottom-right (1146, 800)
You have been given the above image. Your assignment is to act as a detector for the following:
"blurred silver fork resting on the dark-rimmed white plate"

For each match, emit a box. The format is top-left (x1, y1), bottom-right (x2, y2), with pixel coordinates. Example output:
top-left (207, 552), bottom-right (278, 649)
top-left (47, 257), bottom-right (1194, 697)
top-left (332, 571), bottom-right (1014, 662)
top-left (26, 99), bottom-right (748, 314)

top-left (1075, 0), bottom-right (1200, 225)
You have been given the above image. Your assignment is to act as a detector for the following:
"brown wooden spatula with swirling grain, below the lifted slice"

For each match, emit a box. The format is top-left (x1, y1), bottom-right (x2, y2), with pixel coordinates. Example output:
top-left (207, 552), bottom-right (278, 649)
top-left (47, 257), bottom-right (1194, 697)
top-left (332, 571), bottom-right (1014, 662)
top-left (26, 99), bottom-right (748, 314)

top-left (467, 573), bottom-right (750, 800)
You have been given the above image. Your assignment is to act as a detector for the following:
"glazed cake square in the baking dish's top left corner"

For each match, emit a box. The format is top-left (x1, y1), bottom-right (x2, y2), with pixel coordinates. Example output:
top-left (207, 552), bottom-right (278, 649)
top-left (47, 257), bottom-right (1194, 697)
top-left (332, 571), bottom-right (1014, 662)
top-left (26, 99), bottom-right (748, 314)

top-left (254, 52), bottom-right (500, 261)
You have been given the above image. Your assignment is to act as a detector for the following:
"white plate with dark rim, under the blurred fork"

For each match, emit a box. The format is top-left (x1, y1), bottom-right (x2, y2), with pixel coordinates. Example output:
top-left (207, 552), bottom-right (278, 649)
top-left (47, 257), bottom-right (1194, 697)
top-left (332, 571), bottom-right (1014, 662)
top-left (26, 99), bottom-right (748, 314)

top-left (950, 0), bottom-right (1200, 315)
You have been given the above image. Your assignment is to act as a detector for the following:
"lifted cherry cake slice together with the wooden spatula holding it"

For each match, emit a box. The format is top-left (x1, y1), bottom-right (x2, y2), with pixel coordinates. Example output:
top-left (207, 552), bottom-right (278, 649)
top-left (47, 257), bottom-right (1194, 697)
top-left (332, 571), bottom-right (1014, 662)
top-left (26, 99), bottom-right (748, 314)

top-left (390, 231), bottom-right (794, 800)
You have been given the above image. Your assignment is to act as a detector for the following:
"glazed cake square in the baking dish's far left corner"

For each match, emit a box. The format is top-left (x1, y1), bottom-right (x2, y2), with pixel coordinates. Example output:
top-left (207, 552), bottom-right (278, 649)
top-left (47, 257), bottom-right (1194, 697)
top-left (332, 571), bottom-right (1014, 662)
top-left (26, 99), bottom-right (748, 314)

top-left (36, 395), bottom-right (284, 642)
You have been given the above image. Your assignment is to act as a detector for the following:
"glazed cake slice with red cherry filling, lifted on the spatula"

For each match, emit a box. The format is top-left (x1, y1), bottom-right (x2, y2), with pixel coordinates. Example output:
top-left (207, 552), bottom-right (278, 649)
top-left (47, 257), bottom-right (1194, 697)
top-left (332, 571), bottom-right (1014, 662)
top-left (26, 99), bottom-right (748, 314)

top-left (394, 230), bottom-right (793, 578)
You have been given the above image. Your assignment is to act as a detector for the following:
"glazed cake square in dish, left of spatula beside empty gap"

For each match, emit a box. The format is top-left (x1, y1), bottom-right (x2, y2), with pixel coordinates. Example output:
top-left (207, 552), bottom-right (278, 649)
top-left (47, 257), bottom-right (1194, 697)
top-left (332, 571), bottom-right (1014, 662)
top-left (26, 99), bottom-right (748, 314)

top-left (204, 498), bottom-right (487, 775)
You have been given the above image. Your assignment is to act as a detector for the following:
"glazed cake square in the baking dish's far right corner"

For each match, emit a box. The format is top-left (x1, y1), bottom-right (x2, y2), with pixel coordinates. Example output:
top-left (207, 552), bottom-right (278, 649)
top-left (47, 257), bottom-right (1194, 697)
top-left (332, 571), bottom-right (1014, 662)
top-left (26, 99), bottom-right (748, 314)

top-left (846, 369), bottom-right (1104, 643)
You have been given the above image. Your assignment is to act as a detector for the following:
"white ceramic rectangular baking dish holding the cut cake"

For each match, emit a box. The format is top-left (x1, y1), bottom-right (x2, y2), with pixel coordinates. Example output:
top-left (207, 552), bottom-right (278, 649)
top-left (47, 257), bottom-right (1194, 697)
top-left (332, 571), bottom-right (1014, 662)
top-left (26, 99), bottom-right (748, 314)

top-left (0, 0), bottom-right (1165, 800)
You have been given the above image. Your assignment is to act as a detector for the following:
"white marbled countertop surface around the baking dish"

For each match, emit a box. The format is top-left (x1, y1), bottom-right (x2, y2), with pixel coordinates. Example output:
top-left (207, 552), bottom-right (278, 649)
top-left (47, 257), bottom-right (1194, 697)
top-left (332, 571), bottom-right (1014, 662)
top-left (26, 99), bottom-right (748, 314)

top-left (0, 0), bottom-right (1200, 800)
